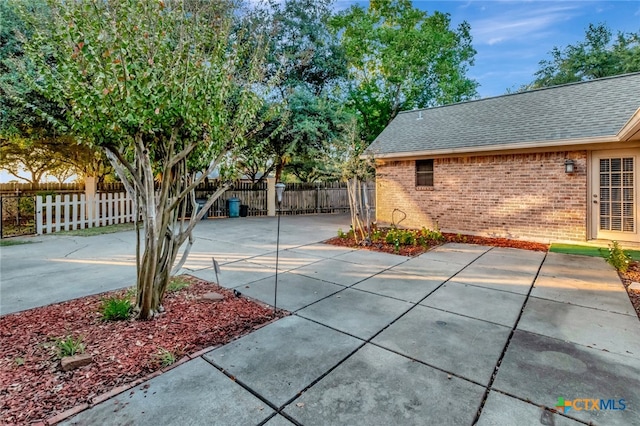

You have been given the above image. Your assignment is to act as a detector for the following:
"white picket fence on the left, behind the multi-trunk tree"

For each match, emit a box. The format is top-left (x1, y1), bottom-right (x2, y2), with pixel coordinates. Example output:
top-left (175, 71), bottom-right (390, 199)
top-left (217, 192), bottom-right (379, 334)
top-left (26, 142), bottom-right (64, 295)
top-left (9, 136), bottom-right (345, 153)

top-left (36, 192), bottom-right (134, 235)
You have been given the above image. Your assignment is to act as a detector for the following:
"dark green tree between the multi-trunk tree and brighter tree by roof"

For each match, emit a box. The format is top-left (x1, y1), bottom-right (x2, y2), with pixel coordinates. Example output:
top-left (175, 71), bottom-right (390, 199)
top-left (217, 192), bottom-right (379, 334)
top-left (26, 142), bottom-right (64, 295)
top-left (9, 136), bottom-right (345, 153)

top-left (243, 0), bottom-right (347, 180)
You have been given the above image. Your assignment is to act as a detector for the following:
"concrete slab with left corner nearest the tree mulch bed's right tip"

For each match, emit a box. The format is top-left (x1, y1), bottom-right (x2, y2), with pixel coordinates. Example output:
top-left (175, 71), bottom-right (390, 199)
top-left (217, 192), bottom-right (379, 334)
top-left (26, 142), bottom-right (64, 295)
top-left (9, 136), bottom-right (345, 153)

top-left (297, 289), bottom-right (413, 340)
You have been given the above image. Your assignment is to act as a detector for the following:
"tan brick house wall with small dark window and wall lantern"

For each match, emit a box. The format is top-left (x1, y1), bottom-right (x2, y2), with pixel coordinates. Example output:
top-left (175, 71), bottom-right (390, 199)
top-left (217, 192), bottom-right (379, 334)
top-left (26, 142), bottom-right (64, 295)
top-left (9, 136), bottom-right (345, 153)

top-left (376, 151), bottom-right (587, 242)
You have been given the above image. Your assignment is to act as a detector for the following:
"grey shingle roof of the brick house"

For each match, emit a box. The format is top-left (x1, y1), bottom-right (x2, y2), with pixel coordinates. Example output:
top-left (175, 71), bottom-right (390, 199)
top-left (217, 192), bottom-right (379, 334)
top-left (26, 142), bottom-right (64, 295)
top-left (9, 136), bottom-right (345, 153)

top-left (365, 73), bottom-right (640, 156)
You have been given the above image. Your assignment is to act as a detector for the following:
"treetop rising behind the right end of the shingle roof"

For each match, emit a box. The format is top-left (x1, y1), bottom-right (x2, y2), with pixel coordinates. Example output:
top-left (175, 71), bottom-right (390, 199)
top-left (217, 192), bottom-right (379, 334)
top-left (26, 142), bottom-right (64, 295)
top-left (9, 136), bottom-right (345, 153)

top-left (523, 24), bottom-right (640, 89)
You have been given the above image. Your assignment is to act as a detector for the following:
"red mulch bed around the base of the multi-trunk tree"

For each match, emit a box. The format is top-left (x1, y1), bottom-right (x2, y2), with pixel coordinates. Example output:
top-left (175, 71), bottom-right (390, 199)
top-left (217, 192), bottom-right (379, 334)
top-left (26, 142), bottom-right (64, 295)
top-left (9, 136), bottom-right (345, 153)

top-left (0, 276), bottom-right (282, 424)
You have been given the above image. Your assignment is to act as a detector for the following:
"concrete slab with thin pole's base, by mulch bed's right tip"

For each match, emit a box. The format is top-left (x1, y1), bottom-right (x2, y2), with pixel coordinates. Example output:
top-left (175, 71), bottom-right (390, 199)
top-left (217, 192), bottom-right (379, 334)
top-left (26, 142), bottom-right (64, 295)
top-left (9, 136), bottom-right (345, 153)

top-left (238, 272), bottom-right (344, 312)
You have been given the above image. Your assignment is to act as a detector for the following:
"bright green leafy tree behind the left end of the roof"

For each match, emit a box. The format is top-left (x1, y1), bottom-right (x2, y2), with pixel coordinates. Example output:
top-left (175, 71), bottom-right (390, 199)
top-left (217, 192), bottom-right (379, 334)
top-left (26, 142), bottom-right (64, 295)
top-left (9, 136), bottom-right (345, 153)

top-left (332, 0), bottom-right (477, 142)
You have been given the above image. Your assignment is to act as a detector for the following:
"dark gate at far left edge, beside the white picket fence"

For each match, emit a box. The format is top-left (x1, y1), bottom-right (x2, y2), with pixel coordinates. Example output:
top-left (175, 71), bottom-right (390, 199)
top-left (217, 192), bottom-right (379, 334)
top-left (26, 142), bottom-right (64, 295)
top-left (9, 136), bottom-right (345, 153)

top-left (0, 195), bottom-right (36, 238)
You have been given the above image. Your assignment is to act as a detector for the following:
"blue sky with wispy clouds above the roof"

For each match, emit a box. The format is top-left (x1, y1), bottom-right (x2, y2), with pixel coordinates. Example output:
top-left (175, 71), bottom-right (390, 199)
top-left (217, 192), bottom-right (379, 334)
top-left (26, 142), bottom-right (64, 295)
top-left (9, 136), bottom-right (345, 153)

top-left (336, 0), bottom-right (640, 97)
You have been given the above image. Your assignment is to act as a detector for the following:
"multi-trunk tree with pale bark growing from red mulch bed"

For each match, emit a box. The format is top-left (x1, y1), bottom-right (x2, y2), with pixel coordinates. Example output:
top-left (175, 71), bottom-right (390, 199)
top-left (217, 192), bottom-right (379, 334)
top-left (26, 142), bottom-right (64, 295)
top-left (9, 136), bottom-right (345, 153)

top-left (15, 0), bottom-right (268, 319)
